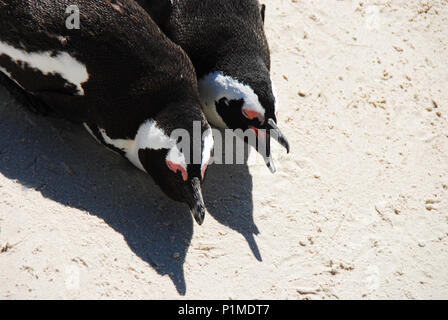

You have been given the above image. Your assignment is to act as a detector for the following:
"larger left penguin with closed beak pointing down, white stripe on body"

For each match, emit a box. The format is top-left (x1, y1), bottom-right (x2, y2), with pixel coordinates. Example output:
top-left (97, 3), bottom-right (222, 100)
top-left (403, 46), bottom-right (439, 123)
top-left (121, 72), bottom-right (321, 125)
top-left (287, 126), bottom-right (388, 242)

top-left (0, 0), bottom-right (213, 224)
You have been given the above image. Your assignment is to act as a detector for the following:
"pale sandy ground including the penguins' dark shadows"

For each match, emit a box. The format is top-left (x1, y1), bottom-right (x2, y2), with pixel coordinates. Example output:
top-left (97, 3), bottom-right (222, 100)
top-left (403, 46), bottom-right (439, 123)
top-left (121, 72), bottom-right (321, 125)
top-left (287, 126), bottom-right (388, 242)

top-left (0, 0), bottom-right (448, 299)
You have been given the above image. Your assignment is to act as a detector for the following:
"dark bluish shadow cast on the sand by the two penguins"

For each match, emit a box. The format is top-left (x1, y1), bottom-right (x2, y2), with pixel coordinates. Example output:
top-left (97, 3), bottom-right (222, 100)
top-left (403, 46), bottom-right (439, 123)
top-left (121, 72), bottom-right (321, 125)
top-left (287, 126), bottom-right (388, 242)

top-left (0, 85), bottom-right (261, 295)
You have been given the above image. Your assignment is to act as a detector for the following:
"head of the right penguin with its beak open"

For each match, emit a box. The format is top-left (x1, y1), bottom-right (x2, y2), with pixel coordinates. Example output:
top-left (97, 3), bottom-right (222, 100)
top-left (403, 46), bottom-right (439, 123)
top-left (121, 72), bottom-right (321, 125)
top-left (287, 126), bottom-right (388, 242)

top-left (199, 71), bottom-right (290, 173)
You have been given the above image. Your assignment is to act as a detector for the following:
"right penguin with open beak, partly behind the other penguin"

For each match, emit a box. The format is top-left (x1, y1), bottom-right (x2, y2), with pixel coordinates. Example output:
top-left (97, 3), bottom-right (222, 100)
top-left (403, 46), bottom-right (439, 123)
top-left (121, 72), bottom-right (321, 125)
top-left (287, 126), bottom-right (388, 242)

top-left (136, 0), bottom-right (290, 173)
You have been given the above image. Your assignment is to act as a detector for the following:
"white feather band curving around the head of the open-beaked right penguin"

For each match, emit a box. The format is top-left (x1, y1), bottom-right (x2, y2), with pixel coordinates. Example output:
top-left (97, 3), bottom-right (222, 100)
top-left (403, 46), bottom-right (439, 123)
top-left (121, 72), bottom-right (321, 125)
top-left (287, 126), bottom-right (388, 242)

top-left (198, 72), bottom-right (265, 128)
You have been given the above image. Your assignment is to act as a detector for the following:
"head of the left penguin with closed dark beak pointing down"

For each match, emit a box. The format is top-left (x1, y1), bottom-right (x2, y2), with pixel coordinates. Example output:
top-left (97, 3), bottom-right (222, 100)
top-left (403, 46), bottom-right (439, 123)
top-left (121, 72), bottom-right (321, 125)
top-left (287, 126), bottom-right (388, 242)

top-left (137, 111), bottom-right (213, 225)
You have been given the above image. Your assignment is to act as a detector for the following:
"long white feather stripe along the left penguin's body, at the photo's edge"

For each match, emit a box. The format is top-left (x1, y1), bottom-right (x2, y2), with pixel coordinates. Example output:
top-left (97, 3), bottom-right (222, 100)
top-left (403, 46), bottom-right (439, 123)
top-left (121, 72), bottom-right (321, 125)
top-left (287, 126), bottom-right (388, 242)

top-left (0, 40), bottom-right (89, 95)
